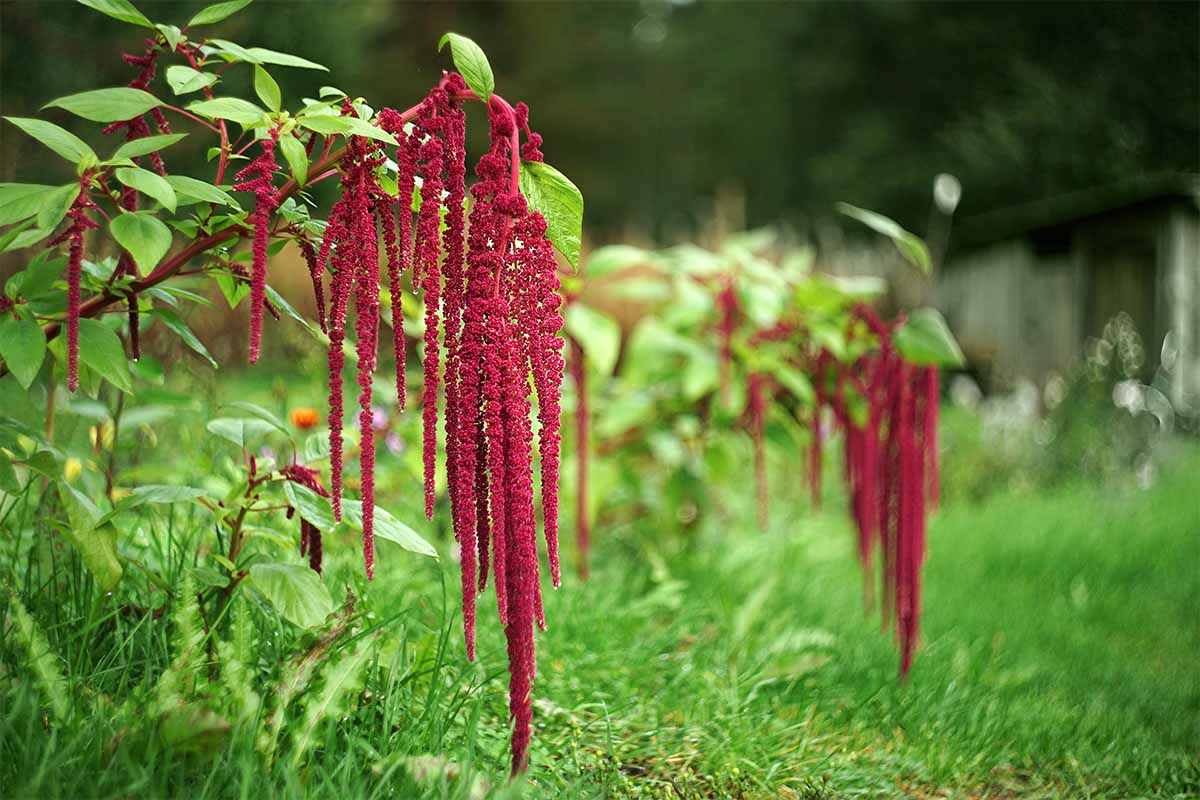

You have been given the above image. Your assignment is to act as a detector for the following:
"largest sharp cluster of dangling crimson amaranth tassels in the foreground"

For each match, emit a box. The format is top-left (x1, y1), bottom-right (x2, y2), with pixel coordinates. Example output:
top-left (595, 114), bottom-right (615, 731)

top-left (301, 74), bottom-right (565, 772)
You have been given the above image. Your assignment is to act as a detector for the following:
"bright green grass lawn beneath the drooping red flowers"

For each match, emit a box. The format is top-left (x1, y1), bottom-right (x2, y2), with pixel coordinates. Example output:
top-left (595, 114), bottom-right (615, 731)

top-left (0, 371), bottom-right (1200, 799)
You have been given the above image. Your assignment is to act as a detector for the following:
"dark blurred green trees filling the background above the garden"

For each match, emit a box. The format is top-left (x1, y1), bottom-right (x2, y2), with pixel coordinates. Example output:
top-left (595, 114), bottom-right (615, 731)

top-left (0, 0), bottom-right (1200, 239)
